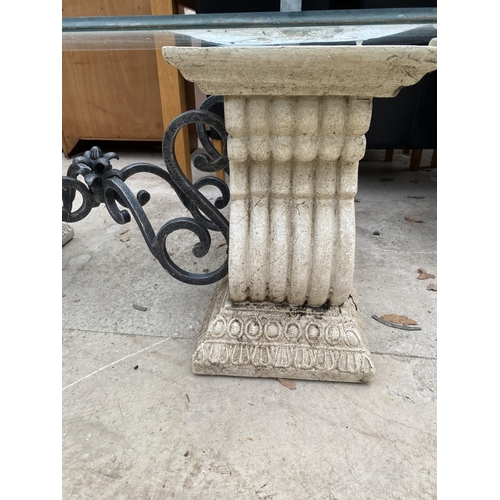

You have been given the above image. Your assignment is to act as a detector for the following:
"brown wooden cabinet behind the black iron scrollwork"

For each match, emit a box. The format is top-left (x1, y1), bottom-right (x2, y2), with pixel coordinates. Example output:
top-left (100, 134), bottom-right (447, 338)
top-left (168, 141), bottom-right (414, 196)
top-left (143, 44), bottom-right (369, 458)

top-left (62, 0), bottom-right (196, 178)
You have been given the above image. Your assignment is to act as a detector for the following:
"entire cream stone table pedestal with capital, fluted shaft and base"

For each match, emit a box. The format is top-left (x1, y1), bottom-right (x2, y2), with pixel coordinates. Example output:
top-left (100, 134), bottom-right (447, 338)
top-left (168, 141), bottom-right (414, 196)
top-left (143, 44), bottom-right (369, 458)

top-left (163, 46), bottom-right (436, 382)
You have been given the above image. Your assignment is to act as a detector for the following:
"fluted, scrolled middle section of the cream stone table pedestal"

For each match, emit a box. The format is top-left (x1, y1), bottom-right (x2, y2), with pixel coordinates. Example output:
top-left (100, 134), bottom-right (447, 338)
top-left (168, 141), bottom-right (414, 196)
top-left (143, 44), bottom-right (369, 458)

top-left (225, 96), bottom-right (371, 306)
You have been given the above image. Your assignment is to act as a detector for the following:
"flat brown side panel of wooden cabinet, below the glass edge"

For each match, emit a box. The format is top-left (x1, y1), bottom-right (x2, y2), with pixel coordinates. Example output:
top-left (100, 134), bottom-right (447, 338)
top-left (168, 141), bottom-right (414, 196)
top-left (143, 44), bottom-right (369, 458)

top-left (62, 50), bottom-right (164, 150)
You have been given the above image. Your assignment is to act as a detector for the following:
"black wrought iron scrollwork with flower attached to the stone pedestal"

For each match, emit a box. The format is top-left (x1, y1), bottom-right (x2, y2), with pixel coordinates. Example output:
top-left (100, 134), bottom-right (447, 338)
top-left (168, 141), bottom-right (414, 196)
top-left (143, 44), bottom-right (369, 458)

top-left (62, 96), bottom-right (229, 285)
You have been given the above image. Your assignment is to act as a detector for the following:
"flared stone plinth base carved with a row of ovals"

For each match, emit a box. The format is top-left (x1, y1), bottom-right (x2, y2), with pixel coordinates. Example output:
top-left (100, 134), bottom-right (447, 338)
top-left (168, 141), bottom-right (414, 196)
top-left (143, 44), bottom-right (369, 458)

top-left (193, 279), bottom-right (375, 382)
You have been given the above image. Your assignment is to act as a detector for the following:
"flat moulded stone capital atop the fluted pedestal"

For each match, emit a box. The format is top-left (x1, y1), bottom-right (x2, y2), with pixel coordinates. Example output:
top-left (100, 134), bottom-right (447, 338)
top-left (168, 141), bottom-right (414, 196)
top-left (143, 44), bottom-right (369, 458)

top-left (163, 45), bottom-right (437, 97)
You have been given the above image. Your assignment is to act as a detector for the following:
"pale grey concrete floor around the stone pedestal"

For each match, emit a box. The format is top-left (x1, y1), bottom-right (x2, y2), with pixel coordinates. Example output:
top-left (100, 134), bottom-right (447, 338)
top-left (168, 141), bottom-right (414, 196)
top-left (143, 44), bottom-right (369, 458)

top-left (62, 146), bottom-right (437, 500)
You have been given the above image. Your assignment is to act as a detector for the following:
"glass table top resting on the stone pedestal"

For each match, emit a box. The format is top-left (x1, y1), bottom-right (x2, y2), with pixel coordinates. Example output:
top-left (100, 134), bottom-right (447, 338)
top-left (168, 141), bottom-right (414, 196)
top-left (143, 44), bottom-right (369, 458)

top-left (62, 8), bottom-right (437, 51)
